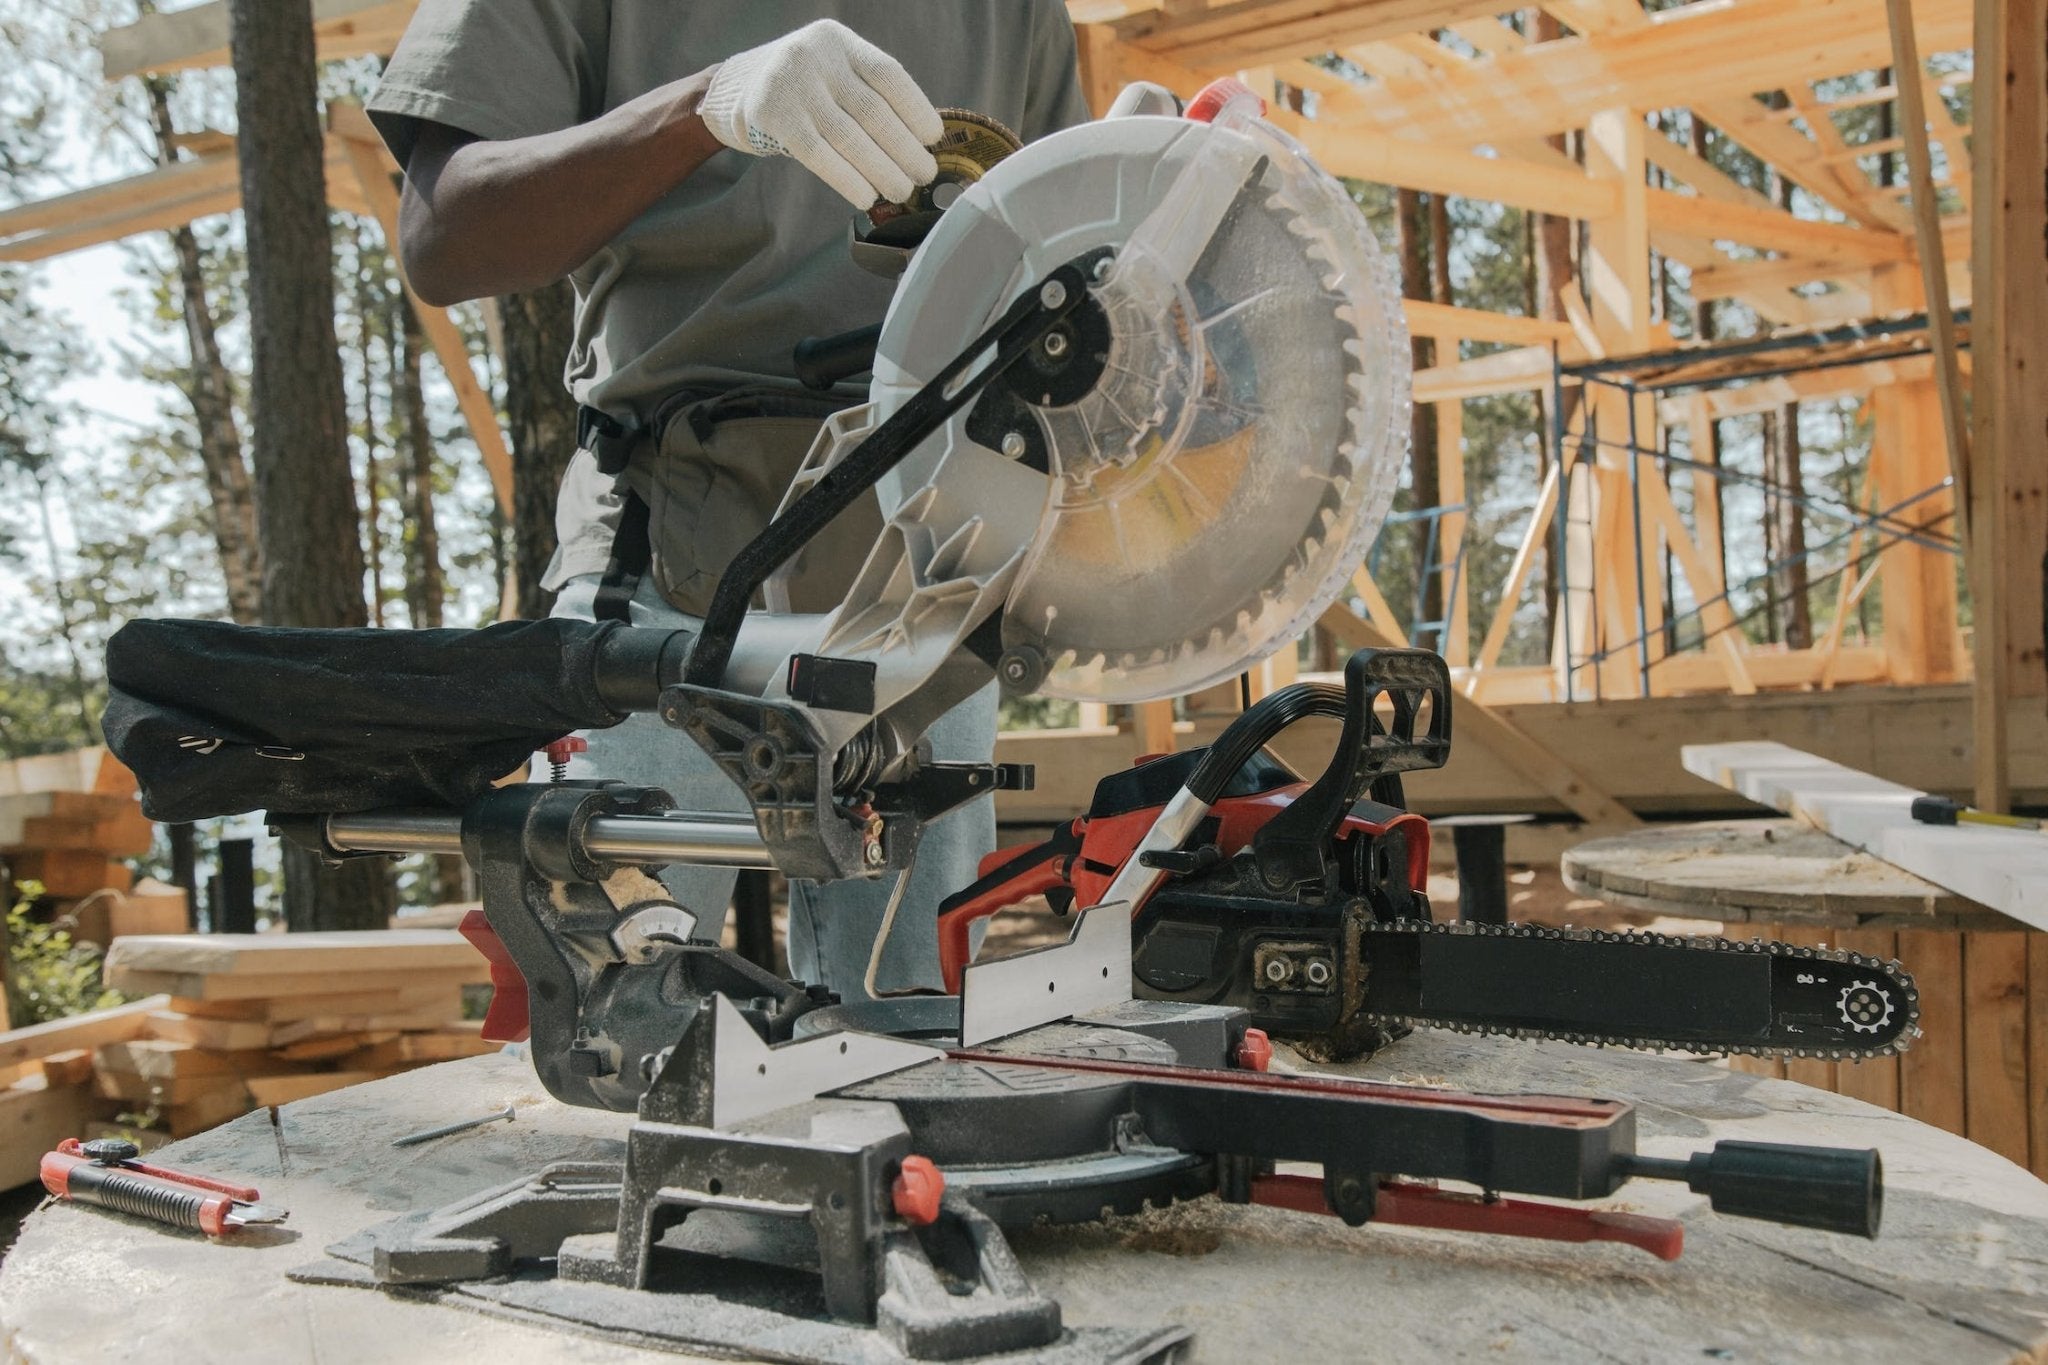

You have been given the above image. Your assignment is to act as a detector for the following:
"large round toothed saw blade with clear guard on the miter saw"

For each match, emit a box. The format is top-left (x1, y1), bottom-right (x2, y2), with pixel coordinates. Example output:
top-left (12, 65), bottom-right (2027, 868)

top-left (877, 115), bottom-right (1411, 702)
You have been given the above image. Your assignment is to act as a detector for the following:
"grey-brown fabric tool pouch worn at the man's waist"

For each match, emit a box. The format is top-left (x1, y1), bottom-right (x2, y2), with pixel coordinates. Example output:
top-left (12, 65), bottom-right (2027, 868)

top-left (625, 389), bottom-right (881, 616)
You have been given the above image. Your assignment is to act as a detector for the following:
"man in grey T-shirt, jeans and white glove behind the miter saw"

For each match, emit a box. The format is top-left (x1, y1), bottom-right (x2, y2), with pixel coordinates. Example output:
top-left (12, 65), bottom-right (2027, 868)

top-left (369, 0), bottom-right (1087, 999)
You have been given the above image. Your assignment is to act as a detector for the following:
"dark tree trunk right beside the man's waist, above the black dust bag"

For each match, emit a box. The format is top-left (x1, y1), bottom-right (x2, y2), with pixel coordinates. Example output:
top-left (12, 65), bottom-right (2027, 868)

top-left (498, 280), bottom-right (575, 620)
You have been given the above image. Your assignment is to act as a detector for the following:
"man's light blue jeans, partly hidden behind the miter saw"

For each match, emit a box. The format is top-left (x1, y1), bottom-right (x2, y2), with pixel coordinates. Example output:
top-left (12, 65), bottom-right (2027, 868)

top-left (555, 575), bottom-right (997, 1001)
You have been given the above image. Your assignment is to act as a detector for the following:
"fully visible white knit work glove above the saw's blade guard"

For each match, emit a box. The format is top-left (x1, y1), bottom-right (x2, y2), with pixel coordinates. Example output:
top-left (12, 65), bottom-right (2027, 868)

top-left (698, 18), bottom-right (946, 209)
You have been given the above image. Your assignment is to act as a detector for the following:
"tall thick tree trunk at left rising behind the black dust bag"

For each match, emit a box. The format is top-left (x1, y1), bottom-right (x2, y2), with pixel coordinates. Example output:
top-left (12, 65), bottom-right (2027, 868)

top-left (227, 0), bottom-right (395, 929)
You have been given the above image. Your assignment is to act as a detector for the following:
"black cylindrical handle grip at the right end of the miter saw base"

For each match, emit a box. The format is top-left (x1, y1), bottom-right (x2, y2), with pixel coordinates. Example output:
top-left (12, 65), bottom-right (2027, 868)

top-left (1620, 1142), bottom-right (1884, 1238)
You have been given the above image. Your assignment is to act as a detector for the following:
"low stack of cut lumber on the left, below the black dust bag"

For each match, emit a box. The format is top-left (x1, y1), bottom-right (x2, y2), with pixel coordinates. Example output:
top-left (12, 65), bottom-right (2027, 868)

top-left (0, 929), bottom-right (498, 1189)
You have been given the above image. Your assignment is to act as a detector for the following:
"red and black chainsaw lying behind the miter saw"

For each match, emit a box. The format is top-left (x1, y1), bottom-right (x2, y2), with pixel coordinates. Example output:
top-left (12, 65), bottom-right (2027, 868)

top-left (938, 651), bottom-right (1919, 1060)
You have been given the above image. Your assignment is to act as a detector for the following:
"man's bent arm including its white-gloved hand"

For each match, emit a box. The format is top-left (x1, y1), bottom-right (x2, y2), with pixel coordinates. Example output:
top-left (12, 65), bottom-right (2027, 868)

top-left (399, 18), bottom-right (944, 305)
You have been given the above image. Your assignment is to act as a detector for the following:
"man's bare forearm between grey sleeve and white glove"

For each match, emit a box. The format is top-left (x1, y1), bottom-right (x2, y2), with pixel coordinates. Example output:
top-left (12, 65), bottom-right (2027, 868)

top-left (399, 72), bottom-right (723, 305)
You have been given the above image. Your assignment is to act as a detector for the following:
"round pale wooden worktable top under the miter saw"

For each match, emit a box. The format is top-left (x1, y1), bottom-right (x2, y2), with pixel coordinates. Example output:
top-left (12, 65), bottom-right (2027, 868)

top-left (0, 1033), bottom-right (2048, 1365)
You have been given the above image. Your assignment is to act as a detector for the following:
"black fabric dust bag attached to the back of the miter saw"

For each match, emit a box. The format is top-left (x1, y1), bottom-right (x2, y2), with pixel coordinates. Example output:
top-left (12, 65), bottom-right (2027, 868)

top-left (102, 620), bottom-right (625, 821)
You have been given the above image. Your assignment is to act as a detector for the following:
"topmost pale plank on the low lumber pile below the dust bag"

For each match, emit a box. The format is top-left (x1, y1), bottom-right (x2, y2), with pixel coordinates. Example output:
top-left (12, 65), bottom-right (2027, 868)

top-left (106, 929), bottom-right (481, 982)
